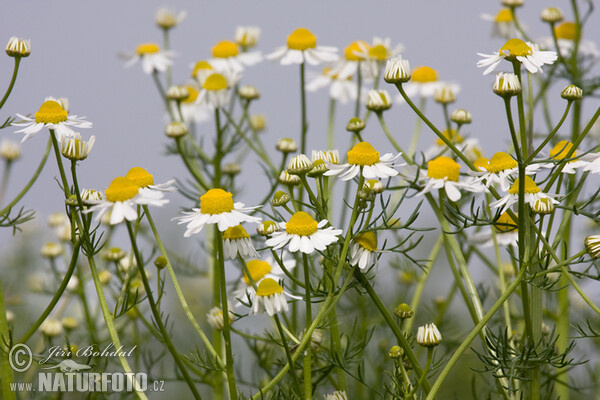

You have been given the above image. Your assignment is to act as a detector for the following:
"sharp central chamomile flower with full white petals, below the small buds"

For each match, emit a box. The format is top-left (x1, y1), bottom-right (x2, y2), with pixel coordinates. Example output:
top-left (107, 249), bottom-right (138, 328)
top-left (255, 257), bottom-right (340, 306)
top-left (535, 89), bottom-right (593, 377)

top-left (266, 211), bottom-right (342, 254)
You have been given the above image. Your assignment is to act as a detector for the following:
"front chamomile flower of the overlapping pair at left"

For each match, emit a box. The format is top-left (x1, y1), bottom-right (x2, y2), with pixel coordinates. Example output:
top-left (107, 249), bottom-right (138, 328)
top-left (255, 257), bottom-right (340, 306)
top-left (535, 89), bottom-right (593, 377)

top-left (84, 176), bottom-right (169, 225)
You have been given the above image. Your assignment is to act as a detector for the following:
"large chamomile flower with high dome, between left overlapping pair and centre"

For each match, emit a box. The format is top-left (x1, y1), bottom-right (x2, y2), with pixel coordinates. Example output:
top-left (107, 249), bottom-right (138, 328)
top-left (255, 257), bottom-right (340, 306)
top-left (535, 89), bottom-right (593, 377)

top-left (173, 188), bottom-right (260, 237)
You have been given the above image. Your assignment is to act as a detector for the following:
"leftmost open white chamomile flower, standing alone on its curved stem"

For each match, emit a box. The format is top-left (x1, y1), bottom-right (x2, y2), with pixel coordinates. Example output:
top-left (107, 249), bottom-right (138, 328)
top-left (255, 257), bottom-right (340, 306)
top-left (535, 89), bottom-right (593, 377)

top-left (12, 97), bottom-right (92, 143)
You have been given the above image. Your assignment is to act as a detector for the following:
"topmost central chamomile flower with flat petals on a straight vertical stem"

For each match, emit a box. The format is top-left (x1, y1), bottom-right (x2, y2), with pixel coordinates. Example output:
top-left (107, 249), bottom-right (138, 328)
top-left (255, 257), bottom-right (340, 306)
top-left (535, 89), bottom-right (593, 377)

top-left (266, 28), bottom-right (338, 65)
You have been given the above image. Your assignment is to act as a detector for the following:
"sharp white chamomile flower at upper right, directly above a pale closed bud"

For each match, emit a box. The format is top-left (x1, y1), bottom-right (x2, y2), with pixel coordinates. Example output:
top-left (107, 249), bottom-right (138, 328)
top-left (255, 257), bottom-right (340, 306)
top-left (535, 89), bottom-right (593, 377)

top-left (477, 38), bottom-right (558, 75)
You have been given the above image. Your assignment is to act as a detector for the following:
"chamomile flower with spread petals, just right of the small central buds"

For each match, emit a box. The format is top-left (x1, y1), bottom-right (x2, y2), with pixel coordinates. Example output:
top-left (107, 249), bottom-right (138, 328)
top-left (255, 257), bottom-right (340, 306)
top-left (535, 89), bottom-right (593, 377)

top-left (325, 142), bottom-right (405, 181)
